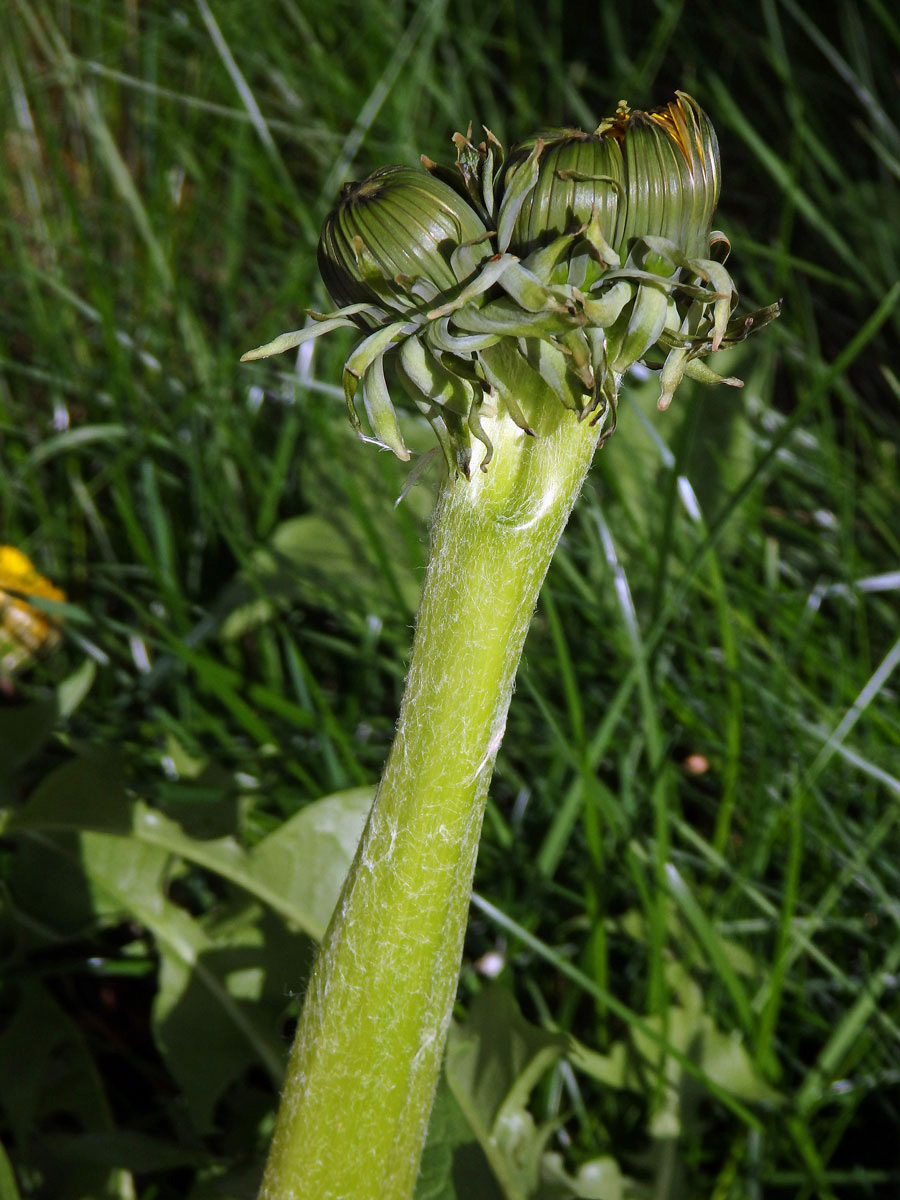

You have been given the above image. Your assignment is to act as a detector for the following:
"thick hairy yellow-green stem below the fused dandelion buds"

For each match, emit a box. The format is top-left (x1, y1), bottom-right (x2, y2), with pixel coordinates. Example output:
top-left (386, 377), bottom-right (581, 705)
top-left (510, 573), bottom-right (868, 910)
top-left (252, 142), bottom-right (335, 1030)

top-left (260, 407), bottom-right (614, 1200)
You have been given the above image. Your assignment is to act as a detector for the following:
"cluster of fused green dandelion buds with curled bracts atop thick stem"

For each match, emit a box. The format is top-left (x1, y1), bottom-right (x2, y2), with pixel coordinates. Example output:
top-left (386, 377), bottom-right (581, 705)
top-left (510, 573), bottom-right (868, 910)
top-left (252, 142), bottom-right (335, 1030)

top-left (244, 92), bottom-right (779, 476)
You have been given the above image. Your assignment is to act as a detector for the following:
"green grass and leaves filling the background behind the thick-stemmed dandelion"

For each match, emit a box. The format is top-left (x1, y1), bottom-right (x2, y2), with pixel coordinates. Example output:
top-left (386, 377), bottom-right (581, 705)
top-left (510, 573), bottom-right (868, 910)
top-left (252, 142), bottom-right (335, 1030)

top-left (0, 0), bottom-right (900, 1200)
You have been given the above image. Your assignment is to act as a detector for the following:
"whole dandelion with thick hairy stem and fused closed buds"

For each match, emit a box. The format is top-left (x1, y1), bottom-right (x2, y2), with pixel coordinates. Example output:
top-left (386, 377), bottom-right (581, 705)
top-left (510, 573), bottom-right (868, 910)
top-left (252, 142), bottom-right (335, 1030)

top-left (245, 92), bottom-right (778, 1200)
